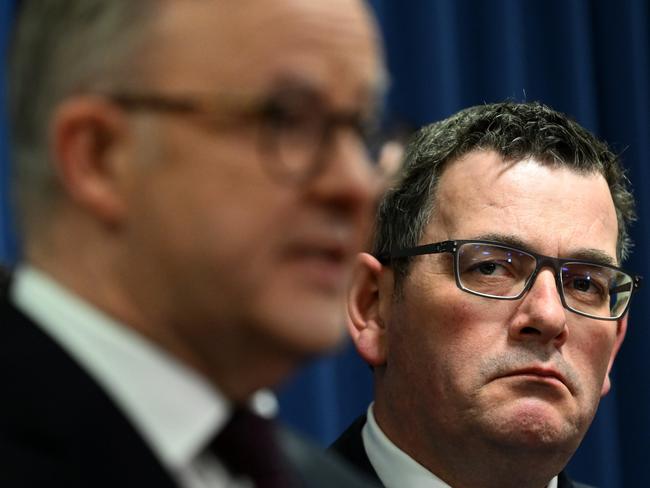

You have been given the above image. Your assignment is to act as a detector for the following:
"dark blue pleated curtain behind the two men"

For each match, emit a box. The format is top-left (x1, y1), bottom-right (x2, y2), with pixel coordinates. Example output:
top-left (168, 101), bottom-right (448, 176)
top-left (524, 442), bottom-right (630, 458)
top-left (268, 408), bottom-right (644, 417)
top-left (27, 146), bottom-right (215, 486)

top-left (0, 0), bottom-right (650, 488)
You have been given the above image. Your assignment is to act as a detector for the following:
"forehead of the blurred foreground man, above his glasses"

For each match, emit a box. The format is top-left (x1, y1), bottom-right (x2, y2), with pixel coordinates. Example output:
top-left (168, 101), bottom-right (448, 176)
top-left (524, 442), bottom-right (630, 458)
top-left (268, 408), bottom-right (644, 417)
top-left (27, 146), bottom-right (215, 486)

top-left (144, 0), bottom-right (386, 103)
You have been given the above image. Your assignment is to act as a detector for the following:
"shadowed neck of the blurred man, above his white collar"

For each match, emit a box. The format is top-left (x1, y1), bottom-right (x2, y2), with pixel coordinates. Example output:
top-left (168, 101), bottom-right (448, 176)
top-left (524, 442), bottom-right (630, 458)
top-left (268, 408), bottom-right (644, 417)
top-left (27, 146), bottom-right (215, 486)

top-left (25, 219), bottom-right (302, 403)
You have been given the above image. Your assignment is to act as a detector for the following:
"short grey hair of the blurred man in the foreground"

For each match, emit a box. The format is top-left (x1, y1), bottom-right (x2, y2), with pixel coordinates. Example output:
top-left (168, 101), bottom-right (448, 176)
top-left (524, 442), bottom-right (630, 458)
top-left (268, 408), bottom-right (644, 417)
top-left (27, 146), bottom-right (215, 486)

top-left (8, 0), bottom-right (162, 242)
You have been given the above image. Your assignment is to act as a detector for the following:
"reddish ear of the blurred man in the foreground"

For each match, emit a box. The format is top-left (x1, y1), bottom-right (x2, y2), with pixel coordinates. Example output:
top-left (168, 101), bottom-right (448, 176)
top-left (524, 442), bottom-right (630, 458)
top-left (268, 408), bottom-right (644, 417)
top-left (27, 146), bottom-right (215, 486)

top-left (50, 96), bottom-right (134, 225)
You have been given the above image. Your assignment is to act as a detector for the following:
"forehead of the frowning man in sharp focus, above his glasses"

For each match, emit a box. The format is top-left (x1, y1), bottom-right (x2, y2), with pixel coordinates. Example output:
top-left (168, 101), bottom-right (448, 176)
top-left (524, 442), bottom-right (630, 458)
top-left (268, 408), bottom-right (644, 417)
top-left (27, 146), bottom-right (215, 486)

top-left (429, 151), bottom-right (617, 258)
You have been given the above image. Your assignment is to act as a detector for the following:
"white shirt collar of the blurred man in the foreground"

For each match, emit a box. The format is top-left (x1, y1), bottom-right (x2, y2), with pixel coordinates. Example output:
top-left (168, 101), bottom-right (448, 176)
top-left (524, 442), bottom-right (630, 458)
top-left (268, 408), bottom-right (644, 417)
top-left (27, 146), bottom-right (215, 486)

top-left (11, 265), bottom-right (275, 488)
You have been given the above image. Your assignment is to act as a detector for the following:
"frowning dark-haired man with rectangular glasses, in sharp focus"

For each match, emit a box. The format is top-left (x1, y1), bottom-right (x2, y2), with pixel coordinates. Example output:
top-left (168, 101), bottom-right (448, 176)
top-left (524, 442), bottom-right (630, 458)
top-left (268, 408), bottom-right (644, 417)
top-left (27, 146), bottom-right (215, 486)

top-left (333, 103), bottom-right (640, 488)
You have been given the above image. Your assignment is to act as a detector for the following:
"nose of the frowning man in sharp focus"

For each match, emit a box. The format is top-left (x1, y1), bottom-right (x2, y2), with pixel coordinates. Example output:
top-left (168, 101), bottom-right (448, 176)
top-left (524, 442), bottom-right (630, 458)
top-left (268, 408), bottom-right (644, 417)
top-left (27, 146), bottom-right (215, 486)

top-left (509, 269), bottom-right (568, 347)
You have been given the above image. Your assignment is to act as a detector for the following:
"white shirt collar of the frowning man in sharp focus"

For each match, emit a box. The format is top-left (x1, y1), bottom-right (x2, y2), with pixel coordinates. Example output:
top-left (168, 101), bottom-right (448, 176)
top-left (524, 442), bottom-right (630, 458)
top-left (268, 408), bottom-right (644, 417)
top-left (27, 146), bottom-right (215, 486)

top-left (361, 403), bottom-right (557, 488)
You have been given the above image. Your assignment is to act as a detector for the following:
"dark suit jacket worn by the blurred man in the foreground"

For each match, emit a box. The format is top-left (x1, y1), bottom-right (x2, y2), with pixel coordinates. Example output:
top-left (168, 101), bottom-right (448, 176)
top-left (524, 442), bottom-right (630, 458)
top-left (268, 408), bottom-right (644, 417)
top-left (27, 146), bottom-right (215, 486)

top-left (0, 274), bottom-right (374, 488)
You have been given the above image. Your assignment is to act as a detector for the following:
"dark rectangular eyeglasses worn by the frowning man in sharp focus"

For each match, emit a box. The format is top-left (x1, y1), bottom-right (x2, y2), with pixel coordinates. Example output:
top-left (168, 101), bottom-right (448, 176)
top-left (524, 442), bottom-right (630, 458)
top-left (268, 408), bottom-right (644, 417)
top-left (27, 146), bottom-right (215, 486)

top-left (377, 240), bottom-right (642, 320)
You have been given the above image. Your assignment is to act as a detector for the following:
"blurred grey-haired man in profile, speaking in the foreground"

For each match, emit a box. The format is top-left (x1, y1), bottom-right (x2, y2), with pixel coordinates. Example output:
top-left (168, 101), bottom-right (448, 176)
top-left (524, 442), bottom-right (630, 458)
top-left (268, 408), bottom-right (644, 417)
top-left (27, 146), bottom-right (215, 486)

top-left (0, 0), bottom-right (385, 488)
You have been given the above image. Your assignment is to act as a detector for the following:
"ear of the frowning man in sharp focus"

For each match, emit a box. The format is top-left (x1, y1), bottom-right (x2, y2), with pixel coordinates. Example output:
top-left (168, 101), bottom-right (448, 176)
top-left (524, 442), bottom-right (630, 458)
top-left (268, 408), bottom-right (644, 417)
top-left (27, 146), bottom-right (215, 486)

top-left (348, 253), bottom-right (392, 367)
